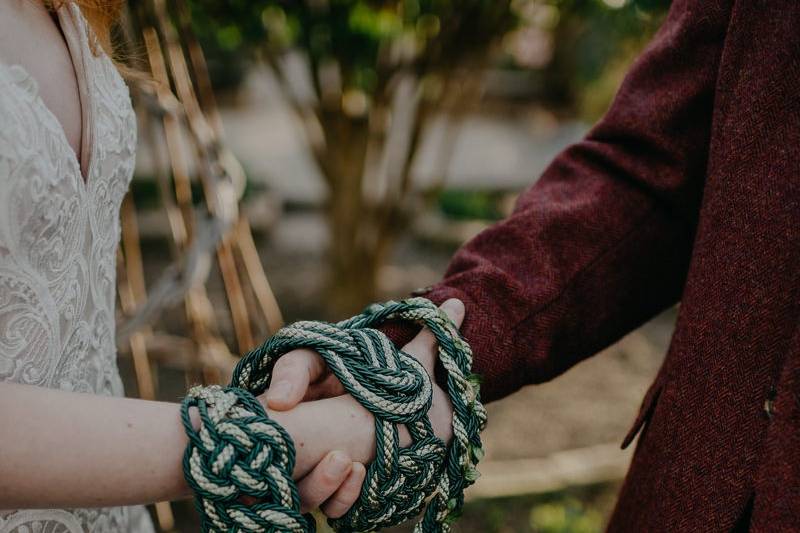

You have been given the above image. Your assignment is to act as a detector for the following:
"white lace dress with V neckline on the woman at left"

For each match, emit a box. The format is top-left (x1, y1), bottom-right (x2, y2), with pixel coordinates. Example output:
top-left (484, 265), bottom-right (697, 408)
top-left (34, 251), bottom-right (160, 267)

top-left (0, 4), bottom-right (153, 533)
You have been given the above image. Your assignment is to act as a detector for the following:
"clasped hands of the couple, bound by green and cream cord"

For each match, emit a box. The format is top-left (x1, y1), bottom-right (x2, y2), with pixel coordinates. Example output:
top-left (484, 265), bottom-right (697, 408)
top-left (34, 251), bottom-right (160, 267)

top-left (250, 299), bottom-right (464, 518)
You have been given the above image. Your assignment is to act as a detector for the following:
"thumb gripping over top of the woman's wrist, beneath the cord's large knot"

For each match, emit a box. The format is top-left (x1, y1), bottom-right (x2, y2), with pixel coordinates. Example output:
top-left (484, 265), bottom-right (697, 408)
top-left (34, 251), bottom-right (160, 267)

top-left (266, 349), bottom-right (327, 411)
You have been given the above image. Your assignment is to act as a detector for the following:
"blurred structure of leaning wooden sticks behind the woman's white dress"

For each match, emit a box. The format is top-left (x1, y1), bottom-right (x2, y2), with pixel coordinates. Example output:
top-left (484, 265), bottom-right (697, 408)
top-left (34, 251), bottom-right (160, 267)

top-left (118, 0), bottom-right (282, 530)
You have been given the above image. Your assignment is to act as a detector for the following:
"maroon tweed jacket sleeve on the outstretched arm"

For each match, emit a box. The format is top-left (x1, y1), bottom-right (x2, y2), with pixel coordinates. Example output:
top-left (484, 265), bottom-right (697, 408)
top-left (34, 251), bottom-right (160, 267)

top-left (389, 0), bottom-right (730, 401)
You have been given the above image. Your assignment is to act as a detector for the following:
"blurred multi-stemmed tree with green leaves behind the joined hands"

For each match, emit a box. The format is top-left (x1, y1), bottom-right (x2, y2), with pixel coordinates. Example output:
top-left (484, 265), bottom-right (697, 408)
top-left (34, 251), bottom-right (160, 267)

top-left (184, 0), bottom-right (516, 312)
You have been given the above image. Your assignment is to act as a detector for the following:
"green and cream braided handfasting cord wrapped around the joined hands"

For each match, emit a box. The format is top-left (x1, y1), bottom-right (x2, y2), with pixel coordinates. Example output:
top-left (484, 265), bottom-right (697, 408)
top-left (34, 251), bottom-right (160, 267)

top-left (184, 298), bottom-right (486, 533)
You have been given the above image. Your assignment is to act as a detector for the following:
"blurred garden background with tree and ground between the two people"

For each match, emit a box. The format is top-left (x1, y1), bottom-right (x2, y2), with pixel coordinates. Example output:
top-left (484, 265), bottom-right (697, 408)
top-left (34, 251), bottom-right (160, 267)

top-left (120, 0), bottom-right (674, 533)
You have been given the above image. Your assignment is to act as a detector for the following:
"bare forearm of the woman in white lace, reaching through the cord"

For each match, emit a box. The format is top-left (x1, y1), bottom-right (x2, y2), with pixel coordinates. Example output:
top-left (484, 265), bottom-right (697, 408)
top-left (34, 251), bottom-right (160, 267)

top-left (0, 383), bottom-right (374, 515)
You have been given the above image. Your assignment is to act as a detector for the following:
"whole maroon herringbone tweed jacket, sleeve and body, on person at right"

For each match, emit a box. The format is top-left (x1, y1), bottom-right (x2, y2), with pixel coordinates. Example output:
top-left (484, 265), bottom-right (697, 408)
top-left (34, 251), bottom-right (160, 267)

top-left (395, 0), bottom-right (800, 532)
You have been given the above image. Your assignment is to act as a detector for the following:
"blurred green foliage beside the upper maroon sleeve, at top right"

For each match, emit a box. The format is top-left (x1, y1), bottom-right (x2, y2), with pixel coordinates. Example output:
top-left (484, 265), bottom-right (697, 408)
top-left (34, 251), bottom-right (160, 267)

top-left (503, 0), bottom-right (671, 117)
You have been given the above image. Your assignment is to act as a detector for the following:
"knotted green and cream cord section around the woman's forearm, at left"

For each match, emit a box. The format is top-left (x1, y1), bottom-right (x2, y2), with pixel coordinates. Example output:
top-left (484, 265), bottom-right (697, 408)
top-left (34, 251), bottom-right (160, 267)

top-left (181, 385), bottom-right (314, 533)
